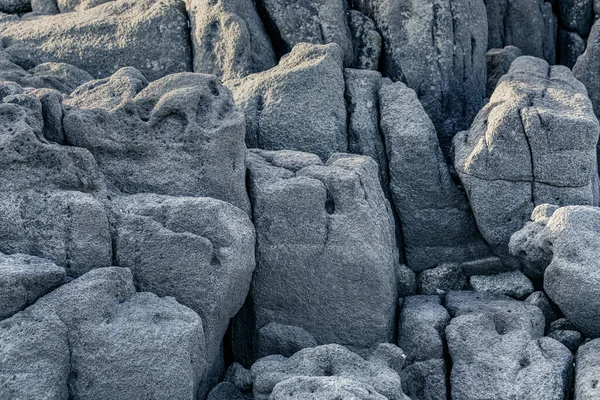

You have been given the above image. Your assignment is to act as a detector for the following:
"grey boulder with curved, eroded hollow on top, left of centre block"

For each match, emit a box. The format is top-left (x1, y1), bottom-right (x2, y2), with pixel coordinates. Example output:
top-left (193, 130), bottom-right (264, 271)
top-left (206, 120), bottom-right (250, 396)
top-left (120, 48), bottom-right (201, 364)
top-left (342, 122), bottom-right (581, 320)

top-left (63, 68), bottom-right (249, 211)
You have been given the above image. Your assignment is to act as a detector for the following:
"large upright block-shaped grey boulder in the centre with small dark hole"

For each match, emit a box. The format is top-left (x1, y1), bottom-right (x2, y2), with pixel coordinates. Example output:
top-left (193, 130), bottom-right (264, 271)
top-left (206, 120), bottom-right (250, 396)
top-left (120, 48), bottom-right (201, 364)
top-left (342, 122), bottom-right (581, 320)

top-left (238, 150), bottom-right (398, 360)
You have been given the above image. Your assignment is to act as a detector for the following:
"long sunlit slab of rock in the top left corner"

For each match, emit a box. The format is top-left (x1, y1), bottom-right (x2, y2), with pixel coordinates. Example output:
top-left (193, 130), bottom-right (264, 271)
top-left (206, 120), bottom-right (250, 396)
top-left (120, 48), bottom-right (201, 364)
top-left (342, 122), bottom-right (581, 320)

top-left (0, 0), bottom-right (192, 80)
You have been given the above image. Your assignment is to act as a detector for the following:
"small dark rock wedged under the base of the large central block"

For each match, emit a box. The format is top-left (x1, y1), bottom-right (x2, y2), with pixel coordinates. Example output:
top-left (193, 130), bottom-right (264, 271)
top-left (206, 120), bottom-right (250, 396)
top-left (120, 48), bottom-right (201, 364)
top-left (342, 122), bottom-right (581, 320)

top-left (258, 322), bottom-right (318, 358)
